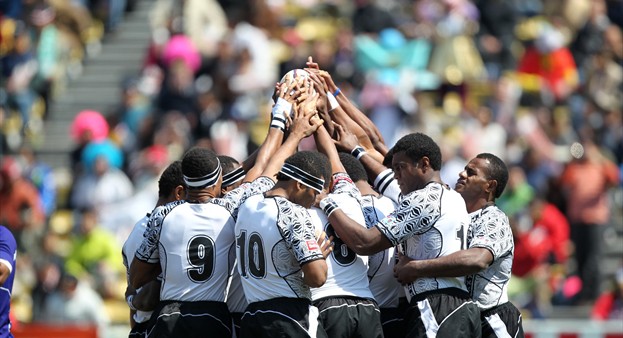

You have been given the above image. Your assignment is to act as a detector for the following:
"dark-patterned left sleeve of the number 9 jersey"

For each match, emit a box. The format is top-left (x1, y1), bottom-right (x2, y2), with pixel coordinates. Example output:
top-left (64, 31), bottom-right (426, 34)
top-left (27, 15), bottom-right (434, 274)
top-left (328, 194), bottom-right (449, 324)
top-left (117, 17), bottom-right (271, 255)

top-left (135, 201), bottom-right (185, 264)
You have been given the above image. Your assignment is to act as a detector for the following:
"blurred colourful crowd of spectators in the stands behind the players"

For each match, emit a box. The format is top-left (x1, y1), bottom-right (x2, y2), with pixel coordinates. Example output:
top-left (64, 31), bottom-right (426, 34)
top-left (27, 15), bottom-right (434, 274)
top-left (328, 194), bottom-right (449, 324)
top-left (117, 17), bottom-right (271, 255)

top-left (0, 0), bottom-right (623, 325)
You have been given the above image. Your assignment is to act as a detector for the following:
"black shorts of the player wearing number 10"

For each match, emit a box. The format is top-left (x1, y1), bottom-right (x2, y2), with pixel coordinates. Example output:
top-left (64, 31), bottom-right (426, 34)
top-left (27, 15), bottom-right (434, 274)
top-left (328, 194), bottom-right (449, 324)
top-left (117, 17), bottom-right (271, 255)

top-left (240, 297), bottom-right (327, 338)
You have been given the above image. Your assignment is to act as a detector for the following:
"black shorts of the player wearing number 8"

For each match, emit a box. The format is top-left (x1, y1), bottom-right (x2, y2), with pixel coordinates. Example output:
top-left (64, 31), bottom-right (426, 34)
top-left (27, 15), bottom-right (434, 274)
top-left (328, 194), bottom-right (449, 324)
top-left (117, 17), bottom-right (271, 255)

top-left (314, 297), bottom-right (383, 338)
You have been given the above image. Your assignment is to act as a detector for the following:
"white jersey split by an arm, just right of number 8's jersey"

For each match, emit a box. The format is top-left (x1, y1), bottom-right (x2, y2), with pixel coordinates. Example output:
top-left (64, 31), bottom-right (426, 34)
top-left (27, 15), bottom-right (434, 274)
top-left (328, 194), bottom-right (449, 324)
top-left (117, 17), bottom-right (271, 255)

top-left (361, 195), bottom-right (404, 308)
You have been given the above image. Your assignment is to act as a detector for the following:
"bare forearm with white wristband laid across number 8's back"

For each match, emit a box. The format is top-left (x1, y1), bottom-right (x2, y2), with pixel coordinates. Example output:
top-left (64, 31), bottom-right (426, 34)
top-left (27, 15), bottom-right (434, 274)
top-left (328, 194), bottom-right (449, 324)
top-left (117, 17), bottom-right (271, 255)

top-left (320, 197), bottom-right (393, 255)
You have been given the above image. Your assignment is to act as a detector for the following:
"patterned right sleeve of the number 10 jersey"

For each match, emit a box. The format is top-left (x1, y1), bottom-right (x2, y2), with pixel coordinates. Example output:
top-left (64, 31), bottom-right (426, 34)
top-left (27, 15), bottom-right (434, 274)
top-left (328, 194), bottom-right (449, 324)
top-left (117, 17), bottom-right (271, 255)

top-left (278, 200), bottom-right (324, 265)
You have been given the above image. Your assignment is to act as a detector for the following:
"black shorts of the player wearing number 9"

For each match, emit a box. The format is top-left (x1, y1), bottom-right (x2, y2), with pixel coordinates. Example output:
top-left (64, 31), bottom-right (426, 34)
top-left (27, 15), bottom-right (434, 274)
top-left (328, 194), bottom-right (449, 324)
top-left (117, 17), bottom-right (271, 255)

top-left (147, 301), bottom-right (233, 338)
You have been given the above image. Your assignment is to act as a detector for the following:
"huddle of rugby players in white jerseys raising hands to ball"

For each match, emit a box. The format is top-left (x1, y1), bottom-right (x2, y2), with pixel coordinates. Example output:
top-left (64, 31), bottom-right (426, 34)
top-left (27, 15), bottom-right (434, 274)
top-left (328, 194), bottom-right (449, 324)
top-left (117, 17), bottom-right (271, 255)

top-left (123, 58), bottom-right (523, 338)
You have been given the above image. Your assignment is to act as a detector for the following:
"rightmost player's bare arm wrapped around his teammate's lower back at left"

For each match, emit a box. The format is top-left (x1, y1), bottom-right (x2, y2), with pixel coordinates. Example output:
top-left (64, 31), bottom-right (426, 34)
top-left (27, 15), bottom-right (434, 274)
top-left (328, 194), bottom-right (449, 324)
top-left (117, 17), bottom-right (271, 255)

top-left (394, 247), bottom-right (493, 284)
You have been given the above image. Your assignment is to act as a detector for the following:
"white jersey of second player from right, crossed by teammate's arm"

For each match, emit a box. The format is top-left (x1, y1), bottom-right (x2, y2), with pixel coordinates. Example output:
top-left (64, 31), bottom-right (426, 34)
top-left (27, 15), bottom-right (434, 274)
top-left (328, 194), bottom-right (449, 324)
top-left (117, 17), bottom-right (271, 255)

top-left (376, 182), bottom-right (469, 300)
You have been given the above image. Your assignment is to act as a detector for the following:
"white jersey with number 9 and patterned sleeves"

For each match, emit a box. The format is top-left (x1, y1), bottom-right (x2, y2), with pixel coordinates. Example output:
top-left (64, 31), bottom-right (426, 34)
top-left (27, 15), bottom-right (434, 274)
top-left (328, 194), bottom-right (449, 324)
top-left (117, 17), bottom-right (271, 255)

top-left (136, 177), bottom-right (274, 302)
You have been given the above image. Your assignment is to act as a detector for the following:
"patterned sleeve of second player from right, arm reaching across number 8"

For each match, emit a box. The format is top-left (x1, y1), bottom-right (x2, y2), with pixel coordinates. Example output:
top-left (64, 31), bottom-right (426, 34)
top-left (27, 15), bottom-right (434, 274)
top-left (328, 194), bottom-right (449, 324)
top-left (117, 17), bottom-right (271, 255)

top-left (376, 184), bottom-right (443, 245)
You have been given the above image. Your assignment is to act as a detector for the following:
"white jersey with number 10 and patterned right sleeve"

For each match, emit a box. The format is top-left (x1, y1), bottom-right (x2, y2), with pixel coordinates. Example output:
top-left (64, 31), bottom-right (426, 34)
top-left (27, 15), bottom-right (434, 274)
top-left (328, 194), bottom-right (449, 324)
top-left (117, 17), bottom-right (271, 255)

top-left (235, 195), bottom-right (324, 303)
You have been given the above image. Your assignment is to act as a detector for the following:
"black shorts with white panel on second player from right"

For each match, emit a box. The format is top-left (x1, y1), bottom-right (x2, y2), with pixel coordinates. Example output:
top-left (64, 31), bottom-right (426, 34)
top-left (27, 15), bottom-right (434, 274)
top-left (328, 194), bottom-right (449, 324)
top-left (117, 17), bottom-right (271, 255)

top-left (405, 288), bottom-right (481, 338)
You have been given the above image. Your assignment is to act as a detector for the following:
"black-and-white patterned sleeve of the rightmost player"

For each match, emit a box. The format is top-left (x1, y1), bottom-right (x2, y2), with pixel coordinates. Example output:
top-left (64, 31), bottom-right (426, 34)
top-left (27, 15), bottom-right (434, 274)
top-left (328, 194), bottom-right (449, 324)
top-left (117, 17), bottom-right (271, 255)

top-left (468, 207), bottom-right (513, 260)
